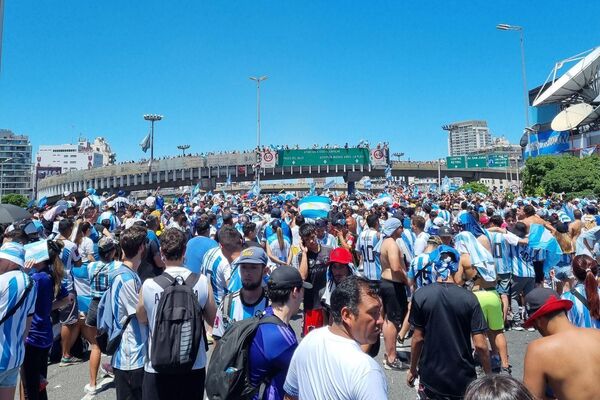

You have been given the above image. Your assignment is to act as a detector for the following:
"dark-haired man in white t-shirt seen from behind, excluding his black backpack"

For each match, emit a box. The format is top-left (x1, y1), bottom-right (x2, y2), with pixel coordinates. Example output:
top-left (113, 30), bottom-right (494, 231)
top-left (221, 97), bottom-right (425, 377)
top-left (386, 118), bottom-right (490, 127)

top-left (137, 228), bottom-right (216, 400)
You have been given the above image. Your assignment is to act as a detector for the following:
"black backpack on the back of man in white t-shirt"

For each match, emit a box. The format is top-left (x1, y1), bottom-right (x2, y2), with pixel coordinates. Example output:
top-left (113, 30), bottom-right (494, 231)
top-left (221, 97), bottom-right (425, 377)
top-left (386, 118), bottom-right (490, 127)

top-left (150, 273), bottom-right (204, 375)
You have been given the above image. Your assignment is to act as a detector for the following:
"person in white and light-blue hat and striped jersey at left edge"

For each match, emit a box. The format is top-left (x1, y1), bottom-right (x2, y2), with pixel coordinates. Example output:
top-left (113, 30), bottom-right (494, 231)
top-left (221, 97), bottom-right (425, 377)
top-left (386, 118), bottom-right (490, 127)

top-left (0, 242), bottom-right (37, 400)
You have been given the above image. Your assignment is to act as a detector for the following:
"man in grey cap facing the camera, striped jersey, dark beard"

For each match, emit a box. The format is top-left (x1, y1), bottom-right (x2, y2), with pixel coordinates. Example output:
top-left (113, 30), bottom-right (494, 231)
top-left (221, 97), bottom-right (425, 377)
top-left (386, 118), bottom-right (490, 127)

top-left (213, 247), bottom-right (269, 340)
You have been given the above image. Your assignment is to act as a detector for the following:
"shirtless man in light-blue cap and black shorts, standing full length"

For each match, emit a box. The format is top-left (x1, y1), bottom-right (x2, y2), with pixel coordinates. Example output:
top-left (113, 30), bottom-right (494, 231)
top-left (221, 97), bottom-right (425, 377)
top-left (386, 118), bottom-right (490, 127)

top-left (379, 218), bottom-right (408, 370)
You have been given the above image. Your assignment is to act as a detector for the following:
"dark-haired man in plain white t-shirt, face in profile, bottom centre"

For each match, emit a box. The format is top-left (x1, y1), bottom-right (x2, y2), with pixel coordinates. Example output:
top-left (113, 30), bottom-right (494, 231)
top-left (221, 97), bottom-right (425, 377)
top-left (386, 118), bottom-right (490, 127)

top-left (284, 276), bottom-right (387, 400)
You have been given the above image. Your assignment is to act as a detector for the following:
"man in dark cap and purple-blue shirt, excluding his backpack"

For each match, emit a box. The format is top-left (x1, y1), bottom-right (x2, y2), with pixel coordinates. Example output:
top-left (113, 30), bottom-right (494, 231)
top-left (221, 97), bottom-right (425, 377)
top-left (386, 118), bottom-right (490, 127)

top-left (248, 266), bottom-right (312, 400)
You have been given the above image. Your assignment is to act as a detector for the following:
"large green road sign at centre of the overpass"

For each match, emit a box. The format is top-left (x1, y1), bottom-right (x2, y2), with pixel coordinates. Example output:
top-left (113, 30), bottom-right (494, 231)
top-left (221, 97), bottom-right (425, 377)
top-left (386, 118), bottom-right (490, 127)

top-left (279, 148), bottom-right (370, 167)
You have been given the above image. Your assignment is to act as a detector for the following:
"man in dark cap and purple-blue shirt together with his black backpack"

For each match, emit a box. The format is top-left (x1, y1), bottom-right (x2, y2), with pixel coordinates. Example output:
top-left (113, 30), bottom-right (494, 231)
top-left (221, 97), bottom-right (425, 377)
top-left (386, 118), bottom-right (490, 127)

top-left (206, 266), bottom-right (312, 400)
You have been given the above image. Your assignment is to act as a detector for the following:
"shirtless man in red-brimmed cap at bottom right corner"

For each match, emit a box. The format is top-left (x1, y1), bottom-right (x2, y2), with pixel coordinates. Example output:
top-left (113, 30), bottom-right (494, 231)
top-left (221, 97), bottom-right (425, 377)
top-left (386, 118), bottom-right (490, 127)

top-left (523, 288), bottom-right (600, 400)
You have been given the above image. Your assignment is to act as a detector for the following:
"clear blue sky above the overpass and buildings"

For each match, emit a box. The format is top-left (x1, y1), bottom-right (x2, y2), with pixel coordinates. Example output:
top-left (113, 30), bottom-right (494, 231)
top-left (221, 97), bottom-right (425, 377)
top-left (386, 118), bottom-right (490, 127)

top-left (0, 0), bottom-right (600, 160)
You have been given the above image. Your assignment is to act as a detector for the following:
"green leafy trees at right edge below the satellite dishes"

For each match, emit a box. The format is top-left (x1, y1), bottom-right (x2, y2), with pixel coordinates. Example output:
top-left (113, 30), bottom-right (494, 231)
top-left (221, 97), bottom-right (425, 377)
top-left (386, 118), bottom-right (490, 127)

top-left (523, 155), bottom-right (600, 197)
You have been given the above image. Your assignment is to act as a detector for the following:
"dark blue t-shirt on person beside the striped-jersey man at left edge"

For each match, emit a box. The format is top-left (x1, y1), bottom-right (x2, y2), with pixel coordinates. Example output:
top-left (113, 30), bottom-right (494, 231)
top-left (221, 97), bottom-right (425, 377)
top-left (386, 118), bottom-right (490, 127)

top-left (25, 266), bottom-right (69, 349)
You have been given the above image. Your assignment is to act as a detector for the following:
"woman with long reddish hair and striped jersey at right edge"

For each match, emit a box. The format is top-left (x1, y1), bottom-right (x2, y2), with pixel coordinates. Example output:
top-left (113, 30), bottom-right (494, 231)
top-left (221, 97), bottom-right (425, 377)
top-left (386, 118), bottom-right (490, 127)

top-left (561, 254), bottom-right (600, 328)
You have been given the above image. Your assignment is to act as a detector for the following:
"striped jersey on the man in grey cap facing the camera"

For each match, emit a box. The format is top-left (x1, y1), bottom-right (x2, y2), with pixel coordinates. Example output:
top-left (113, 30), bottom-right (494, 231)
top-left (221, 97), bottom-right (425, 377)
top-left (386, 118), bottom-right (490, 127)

top-left (213, 291), bottom-right (269, 338)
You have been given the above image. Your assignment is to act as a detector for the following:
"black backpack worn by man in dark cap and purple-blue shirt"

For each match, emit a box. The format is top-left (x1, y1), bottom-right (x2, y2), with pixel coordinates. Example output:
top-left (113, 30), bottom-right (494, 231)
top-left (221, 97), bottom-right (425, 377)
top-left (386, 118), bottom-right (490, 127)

top-left (206, 315), bottom-right (286, 400)
